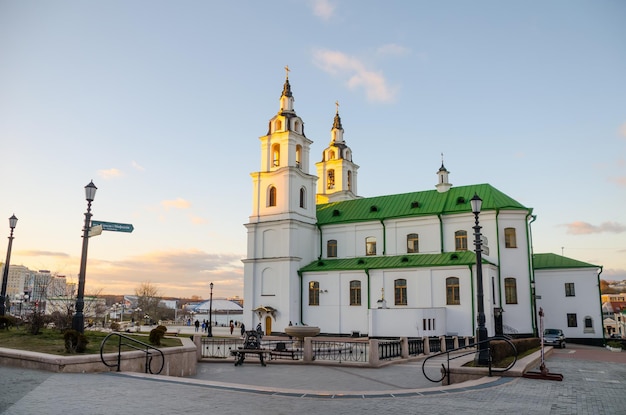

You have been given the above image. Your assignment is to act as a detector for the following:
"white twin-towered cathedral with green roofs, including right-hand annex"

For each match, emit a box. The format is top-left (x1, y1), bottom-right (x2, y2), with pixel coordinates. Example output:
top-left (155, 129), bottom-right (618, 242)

top-left (243, 76), bottom-right (603, 343)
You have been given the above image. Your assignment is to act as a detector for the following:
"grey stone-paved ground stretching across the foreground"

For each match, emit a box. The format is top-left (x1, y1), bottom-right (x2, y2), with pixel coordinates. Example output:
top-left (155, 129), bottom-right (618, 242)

top-left (0, 345), bottom-right (626, 415)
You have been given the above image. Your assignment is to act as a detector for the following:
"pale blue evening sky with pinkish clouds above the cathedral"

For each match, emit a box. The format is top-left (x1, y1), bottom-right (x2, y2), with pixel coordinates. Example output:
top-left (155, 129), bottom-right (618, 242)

top-left (0, 0), bottom-right (626, 298)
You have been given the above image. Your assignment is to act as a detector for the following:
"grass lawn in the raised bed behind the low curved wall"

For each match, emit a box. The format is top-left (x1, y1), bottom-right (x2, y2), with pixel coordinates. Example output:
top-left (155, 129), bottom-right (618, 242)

top-left (0, 327), bottom-right (182, 356)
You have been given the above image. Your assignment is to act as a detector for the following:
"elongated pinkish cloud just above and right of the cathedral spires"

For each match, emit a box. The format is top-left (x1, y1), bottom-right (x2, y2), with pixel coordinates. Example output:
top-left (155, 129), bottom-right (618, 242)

top-left (313, 49), bottom-right (397, 103)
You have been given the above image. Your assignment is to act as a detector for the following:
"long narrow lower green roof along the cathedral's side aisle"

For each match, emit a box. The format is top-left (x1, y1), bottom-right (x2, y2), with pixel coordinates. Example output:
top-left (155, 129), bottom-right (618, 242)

top-left (300, 251), bottom-right (489, 272)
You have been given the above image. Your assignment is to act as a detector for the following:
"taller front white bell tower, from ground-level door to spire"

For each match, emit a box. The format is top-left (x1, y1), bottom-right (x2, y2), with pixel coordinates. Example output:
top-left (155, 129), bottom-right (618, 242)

top-left (243, 67), bottom-right (319, 331)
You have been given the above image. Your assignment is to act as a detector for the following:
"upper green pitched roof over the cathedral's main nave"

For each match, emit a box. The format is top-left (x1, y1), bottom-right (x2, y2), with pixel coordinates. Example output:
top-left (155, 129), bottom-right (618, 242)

top-left (317, 184), bottom-right (532, 226)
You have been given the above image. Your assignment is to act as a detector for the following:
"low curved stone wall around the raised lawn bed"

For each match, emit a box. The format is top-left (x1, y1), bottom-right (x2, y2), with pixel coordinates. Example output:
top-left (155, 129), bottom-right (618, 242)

top-left (0, 337), bottom-right (198, 377)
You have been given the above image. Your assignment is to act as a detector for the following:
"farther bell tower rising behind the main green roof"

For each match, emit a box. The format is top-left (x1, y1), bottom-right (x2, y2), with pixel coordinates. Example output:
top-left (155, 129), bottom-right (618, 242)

top-left (315, 102), bottom-right (359, 204)
